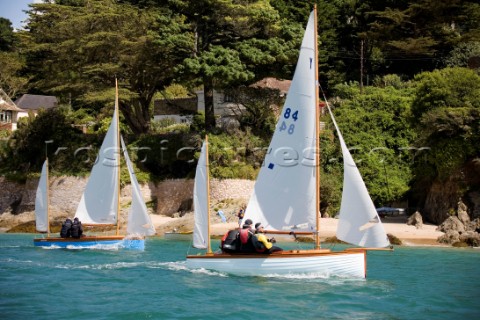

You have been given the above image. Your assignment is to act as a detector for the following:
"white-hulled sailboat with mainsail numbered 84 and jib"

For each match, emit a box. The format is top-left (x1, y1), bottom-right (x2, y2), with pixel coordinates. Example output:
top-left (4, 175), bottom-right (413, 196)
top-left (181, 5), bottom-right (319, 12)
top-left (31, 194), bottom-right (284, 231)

top-left (187, 8), bottom-right (389, 278)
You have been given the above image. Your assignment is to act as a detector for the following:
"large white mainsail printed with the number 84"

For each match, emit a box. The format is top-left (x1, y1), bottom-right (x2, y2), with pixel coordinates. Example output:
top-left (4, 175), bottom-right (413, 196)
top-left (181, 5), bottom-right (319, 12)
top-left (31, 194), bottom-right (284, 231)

top-left (244, 12), bottom-right (318, 230)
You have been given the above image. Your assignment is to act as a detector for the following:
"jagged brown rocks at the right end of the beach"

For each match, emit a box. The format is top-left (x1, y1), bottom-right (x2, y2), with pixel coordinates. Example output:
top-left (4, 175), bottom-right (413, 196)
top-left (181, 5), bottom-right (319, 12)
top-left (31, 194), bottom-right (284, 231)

top-left (437, 201), bottom-right (480, 247)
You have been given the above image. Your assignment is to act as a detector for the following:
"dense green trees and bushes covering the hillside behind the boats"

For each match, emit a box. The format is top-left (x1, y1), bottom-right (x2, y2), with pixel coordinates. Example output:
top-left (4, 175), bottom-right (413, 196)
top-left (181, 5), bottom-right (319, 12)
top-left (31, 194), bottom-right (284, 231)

top-left (0, 0), bottom-right (480, 215)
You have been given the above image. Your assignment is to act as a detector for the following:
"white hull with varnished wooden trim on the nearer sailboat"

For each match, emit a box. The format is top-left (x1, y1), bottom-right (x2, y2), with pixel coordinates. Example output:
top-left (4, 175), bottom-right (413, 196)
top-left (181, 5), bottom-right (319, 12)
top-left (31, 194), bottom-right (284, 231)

top-left (187, 249), bottom-right (366, 278)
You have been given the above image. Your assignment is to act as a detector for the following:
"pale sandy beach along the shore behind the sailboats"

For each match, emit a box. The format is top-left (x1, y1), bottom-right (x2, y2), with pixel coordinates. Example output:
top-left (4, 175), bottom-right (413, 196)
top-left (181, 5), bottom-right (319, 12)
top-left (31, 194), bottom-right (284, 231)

top-left (151, 215), bottom-right (443, 246)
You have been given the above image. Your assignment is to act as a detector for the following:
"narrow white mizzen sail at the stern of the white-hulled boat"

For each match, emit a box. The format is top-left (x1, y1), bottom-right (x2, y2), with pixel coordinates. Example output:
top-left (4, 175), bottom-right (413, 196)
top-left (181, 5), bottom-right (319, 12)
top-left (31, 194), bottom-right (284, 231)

top-left (193, 142), bottom-right (209, 249)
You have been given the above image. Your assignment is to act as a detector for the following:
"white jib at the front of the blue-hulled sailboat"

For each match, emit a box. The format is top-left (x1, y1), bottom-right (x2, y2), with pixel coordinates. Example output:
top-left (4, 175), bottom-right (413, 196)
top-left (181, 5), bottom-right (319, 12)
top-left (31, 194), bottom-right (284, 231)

top-left (120, 136), bottom-right (155, 236)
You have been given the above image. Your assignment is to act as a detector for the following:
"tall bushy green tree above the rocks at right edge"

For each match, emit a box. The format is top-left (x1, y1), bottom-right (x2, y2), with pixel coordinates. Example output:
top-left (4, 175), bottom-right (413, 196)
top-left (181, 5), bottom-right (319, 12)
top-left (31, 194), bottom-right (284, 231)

top-left (412, 68), bottom-right (480, 223)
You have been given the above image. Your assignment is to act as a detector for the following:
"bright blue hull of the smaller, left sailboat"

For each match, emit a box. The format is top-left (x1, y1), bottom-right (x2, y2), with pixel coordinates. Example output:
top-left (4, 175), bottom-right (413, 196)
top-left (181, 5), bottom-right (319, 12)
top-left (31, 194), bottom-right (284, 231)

top-left (33, 236), bottom-right (145, 250)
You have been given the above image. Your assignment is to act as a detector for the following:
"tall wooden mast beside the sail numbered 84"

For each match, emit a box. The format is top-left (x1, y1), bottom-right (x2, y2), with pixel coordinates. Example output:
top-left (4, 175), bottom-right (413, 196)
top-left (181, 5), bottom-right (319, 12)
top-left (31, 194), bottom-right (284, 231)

top-left (313, 4), bottom-right (320, 249)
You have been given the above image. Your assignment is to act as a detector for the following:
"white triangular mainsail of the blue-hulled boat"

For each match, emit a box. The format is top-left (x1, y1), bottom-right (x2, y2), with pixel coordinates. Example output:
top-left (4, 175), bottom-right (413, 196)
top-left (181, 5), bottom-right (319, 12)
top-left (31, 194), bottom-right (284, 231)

top-left (75, 108), bottom-right (120, 224)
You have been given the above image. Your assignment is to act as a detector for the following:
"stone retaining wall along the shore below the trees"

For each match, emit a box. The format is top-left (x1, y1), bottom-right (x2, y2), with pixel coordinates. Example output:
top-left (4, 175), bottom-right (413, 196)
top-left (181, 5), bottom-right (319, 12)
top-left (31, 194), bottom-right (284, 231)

top-left (0, 177), bottom-right (254, 216)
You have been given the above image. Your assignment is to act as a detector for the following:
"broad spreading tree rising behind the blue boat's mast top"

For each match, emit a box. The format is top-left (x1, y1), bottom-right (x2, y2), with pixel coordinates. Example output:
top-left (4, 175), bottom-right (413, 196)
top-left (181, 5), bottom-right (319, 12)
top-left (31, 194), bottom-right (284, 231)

top-left (23, 0), bottom-right (192, 134)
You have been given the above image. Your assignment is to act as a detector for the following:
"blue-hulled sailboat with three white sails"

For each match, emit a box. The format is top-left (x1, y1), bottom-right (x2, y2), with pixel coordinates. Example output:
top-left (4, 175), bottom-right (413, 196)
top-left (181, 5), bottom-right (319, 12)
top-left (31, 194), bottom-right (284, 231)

top-left (34, 80), bottom-right (155, 250)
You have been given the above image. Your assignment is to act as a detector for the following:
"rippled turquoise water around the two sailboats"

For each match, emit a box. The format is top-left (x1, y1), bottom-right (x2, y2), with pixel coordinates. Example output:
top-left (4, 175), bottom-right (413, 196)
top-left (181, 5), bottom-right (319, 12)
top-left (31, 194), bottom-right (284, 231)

top-left (0, 234), bottom-right (480, 319)
